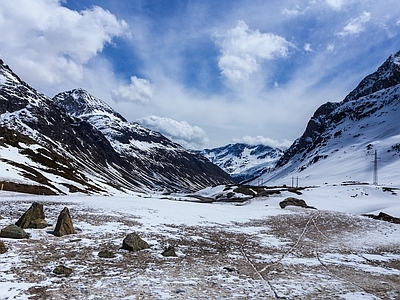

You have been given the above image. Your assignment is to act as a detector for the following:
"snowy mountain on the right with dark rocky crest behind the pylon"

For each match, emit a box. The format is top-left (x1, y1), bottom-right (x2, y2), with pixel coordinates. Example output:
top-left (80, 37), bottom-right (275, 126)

top-left (253, 52), bottom-right (400, 184)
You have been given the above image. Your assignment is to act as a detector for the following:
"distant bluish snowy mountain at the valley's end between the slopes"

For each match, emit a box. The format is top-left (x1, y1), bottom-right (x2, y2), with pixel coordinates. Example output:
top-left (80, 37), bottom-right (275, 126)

top-left (198, 143), bottom-right (285, 182)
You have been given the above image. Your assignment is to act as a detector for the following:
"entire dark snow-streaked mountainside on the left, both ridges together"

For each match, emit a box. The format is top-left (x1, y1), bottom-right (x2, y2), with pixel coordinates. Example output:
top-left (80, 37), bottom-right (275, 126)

top-left (0, 61), bottom-right (231, 194)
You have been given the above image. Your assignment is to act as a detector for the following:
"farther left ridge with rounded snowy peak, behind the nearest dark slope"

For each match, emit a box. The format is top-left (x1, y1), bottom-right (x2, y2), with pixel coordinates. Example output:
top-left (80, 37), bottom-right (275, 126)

top-left (53, 89), bottom-right (231, 190)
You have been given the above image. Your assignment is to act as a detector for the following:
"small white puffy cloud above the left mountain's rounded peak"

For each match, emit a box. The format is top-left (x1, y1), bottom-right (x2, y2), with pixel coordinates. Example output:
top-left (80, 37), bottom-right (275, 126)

top-left (111, 76), bottom-right (154, 104)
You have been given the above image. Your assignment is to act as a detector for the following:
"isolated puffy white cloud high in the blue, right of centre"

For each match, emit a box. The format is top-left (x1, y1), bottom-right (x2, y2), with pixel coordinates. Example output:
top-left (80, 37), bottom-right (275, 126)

top-left (216, 21), bottom-right (291, 83)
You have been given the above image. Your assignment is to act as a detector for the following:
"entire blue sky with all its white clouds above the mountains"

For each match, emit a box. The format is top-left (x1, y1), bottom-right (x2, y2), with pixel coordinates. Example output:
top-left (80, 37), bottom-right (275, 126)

top-left (0, 0), bottom-right (400, 149)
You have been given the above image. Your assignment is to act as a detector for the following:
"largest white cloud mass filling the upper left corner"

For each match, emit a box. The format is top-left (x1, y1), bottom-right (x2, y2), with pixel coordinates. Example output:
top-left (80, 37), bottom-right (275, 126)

top-left (0, 0), bottom-right (128, 91)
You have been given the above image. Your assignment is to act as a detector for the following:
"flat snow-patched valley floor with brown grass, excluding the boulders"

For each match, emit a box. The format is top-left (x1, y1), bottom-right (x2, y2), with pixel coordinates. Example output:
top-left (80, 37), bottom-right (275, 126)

top-left (0, 185), bottom-right (400, 299)
